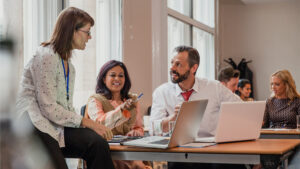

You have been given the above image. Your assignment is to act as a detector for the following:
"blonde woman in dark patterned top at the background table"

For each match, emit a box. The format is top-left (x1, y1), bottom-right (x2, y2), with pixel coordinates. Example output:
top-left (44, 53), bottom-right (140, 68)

top-left (263, 70), bottom-right (300, 128)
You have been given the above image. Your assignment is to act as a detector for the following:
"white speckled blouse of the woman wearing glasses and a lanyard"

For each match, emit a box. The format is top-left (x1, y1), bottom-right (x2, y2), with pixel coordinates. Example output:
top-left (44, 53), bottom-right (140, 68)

top-left (16, 45), bottom-right (82, 147)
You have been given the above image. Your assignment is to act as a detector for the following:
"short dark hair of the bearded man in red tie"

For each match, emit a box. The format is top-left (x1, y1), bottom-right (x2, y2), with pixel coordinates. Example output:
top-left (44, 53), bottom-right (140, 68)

top-left (174, 45), bottom-right (200, 72)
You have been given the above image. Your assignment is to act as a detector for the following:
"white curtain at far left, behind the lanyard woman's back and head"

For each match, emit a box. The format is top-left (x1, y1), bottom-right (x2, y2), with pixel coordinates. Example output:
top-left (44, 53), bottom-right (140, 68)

top-left (23, 0), bottom-right (63, 65)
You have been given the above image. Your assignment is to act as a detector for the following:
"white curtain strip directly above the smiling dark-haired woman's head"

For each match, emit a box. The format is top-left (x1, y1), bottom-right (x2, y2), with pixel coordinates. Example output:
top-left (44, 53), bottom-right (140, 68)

top-left (96, 0), bottom-right (123, 71)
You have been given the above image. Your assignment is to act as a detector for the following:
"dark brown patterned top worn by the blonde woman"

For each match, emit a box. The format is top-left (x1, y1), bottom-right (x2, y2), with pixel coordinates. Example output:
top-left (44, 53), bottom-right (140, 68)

top-left (263, 97), bottom-right (300, 128)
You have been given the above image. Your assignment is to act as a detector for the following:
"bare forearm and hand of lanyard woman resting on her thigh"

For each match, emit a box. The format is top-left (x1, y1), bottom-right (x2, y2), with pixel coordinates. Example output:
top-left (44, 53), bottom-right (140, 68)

top-left (81, 118), bottom-right (113, 140)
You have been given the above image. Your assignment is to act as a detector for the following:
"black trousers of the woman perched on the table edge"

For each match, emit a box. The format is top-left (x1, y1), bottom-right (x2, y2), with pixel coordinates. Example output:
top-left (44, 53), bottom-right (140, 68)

top-left (22, 113), bottom-right (114, 169)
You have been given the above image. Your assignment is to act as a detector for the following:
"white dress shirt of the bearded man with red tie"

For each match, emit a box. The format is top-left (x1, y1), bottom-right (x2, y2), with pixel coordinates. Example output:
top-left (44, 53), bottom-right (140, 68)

top-left (150, 77), bottom-right (242, 137)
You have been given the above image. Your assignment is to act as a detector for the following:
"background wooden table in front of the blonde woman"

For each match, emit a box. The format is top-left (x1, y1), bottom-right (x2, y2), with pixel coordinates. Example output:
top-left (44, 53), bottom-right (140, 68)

top-left (260, 129), bottom-right (300, 139)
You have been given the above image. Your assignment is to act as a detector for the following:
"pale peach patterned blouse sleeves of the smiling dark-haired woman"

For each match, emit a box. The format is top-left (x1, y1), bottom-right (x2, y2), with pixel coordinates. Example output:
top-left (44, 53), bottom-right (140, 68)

top-left (87, 97), bottom-right (144, 135)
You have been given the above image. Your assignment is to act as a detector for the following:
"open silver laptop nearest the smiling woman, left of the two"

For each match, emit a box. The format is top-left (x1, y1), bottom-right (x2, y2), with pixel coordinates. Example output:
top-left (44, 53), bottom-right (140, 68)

top-left (123, 99), bottom-right (208, 149)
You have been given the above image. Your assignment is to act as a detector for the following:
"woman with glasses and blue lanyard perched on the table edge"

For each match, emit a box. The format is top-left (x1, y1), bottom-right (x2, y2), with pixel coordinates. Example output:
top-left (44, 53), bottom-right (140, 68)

top-left (17, 7), bottom-right (114, 169)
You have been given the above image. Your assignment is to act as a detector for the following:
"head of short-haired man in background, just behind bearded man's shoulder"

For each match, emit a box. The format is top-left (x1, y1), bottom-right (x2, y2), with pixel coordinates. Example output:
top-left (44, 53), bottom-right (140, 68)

top-left (218, 67), bottom-right (240, 93)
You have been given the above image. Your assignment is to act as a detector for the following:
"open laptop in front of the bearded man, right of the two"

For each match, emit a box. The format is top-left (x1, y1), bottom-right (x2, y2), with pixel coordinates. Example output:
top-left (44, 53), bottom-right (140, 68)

top-left (195, 101), bottom-right (266, 143)
